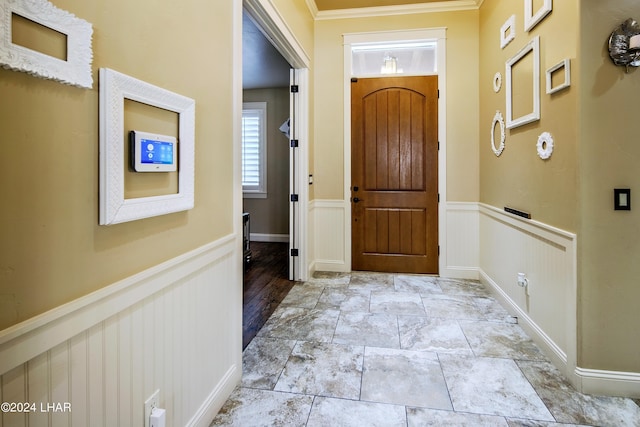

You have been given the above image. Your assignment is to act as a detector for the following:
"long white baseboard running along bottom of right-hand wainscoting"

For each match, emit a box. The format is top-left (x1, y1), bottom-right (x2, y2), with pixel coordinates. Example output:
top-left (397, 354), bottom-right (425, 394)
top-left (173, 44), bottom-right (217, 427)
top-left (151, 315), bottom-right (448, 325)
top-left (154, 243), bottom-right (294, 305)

top-left (480, 269), bottom-right (570, 377)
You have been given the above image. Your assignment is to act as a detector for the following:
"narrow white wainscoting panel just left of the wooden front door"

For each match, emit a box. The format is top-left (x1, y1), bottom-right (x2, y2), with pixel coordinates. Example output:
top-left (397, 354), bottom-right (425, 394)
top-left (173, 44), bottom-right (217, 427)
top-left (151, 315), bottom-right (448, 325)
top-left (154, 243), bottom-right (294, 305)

top-left (309, 200), bottom-right (351, 273)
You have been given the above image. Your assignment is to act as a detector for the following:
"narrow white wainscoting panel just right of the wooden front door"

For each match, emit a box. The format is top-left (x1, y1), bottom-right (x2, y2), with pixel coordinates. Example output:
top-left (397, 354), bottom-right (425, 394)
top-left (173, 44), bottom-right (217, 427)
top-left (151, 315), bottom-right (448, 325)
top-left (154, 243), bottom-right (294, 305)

top-left (440, 202), bottom-right (480, 280)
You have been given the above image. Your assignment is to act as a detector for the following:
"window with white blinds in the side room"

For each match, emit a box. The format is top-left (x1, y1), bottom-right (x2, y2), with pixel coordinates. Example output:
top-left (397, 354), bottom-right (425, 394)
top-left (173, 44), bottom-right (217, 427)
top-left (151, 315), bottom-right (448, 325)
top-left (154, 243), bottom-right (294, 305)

top-left (242, 102), bottom-right (267, 197)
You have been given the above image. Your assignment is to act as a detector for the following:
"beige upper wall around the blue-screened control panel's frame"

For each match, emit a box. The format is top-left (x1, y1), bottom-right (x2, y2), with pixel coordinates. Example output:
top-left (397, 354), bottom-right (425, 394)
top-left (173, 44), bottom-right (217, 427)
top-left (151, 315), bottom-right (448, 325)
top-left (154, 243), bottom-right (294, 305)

top-left (0, 0), bottom-right (234, 329)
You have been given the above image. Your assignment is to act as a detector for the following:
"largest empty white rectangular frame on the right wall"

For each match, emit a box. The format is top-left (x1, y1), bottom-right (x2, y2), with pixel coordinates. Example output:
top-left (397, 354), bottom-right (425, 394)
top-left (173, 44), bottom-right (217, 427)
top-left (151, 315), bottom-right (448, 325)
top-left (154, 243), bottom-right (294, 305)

top-left (505, 37), bottom-right (540, 129)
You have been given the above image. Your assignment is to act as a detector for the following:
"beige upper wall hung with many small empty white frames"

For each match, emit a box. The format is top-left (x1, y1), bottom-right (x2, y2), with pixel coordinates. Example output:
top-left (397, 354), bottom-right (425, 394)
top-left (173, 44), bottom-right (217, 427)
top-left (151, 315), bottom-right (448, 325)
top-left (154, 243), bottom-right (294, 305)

top-left (478, 0), bottom-right (579, 232)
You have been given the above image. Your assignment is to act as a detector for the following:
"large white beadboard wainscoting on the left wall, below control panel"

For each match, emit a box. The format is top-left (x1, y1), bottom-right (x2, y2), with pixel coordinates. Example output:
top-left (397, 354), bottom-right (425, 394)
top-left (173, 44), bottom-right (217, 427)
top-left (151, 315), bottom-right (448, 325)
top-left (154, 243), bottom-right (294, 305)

top-left (0, 236), bottom-right (242, 427)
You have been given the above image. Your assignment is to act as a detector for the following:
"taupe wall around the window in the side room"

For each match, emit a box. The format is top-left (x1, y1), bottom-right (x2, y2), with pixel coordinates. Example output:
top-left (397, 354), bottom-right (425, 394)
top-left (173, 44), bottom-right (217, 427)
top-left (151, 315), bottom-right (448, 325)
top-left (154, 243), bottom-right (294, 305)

top-left (243, 87), bottom-right (290, 234)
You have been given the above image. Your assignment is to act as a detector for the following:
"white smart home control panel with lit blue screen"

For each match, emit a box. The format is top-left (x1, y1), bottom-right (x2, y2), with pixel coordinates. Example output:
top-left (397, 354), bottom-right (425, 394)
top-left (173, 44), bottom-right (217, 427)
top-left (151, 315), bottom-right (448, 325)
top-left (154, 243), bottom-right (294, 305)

top-left (129, 130), bottom-right (178, 172)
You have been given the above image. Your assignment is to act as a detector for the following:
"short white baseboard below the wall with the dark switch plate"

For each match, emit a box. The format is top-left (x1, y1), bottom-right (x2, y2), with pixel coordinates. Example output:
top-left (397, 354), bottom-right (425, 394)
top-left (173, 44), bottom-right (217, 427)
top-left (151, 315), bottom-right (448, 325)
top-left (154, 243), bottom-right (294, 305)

top-left (574, 368), bottom-right (640, 399)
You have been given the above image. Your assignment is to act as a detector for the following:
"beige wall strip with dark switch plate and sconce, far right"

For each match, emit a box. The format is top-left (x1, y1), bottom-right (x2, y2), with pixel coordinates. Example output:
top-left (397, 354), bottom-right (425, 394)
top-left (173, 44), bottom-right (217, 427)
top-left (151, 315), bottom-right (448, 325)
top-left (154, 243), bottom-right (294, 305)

top-left (580, 0), bottom-right (640, 372)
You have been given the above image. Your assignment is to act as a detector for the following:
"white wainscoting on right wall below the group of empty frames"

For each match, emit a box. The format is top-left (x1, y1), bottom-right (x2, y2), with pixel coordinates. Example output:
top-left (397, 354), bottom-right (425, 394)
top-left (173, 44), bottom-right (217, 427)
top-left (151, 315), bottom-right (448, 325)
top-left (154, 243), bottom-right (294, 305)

top-left (479, 204), bottom-right (577, 381)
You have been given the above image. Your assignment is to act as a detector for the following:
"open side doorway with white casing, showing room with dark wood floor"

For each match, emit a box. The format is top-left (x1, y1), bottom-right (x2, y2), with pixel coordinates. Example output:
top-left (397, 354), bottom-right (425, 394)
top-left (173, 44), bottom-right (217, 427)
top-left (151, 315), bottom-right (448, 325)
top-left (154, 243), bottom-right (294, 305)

top-left (242, 0), bottom-right (309, 348)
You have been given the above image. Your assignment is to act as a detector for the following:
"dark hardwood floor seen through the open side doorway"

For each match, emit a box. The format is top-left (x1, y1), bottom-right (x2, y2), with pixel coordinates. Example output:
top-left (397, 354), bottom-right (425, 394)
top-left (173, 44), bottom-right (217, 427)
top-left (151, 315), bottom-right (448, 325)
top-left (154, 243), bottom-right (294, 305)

top-left (242, 242), bottom-right (294, 349)
